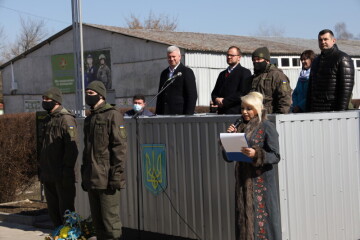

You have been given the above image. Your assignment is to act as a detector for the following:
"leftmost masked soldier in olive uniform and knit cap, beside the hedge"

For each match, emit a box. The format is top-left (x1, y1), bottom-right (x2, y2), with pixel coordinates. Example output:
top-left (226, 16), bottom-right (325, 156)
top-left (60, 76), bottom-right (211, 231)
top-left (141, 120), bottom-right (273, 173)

top-left (39, 88), bottom-right (78, 228)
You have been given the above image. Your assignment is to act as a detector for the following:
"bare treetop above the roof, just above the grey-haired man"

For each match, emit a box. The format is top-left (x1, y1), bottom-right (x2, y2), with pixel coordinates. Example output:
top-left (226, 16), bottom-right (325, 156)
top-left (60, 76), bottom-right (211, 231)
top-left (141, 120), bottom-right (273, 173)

top-left (125, 11), bottom-right (178, 31)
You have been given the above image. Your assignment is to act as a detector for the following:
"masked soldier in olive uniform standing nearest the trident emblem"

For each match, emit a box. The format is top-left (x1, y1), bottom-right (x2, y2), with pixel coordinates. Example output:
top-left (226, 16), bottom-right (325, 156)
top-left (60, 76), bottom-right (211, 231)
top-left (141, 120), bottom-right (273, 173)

top-left (81, 81), bottom-right (127, 240)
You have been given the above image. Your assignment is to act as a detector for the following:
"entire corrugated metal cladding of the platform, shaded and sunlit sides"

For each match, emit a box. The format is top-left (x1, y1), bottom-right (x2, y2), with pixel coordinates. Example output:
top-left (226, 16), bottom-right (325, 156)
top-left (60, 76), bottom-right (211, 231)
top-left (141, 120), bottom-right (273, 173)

top-left (76, 111), bottom-right (360, 240)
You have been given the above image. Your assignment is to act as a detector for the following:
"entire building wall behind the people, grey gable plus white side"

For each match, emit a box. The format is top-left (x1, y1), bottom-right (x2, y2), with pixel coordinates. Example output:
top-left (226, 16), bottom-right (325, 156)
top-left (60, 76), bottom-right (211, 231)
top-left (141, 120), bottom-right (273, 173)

top-left (2, 26), bottom-right (360, 113)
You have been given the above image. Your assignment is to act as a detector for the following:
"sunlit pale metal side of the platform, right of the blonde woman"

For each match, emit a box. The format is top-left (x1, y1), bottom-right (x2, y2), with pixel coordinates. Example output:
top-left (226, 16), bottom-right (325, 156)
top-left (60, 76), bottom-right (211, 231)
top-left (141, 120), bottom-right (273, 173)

top-left (276, 111), bottom-right (360, 240)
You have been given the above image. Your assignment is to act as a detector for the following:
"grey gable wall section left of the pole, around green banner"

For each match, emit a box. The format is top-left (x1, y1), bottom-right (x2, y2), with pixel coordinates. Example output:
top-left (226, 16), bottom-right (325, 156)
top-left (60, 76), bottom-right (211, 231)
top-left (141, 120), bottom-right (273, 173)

top-left (2, 32), bottom-right (75, 113)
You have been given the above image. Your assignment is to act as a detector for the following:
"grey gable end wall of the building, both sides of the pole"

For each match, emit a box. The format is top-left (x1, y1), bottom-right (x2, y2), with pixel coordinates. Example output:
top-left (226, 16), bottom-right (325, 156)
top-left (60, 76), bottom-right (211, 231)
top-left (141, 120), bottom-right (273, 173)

top-left (2, 26), bottom-right (168, 113)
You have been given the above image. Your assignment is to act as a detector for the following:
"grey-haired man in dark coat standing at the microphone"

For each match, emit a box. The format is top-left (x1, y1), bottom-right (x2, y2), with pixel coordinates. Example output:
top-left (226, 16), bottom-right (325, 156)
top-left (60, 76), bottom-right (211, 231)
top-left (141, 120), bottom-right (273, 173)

top-left (156, 46), bottom-right (197, 115)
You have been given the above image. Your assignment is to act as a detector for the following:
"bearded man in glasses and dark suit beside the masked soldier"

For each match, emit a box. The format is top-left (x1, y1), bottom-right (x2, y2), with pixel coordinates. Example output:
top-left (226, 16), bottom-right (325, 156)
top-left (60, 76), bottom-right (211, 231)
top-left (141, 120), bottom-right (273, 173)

top-left (211, 46), bottom-right (251, 114)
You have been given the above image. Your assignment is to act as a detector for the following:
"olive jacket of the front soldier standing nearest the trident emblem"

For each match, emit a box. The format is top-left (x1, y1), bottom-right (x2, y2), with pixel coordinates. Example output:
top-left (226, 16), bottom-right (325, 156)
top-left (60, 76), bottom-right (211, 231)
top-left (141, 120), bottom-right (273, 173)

top-left (81, 103), bottom-right (127, 190)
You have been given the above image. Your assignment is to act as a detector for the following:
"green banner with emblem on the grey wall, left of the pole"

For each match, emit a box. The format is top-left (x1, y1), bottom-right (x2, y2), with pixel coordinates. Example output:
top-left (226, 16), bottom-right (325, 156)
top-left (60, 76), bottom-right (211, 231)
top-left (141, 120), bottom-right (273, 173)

top-left (51, 53), bottom-right (75, 93)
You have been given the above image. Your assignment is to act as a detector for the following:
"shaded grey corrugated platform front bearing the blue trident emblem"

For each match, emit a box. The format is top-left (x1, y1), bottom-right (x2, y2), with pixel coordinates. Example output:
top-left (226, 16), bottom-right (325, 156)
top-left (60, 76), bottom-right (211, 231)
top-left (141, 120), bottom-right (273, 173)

top-left (124, 116), bottom-right (236, 239)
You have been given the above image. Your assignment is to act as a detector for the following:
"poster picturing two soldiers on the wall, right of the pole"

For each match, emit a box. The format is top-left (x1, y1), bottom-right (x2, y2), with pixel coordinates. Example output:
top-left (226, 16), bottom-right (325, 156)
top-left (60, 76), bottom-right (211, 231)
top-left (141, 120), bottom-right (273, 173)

top-left (84, 50), bottom-right (112, 89)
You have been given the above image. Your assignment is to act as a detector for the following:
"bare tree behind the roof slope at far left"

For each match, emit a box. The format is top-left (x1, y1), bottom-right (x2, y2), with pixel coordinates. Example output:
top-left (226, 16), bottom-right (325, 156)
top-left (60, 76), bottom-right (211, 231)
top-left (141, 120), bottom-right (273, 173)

top-left (1, 18), bottom-right (47, 60)
